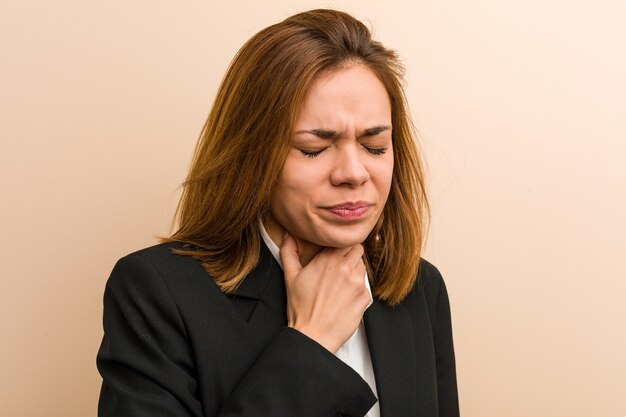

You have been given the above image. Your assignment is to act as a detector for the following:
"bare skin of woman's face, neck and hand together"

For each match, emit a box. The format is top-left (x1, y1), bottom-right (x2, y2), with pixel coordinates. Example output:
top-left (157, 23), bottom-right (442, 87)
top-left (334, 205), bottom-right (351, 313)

top-left (265, 64), bottom-right (393, 353)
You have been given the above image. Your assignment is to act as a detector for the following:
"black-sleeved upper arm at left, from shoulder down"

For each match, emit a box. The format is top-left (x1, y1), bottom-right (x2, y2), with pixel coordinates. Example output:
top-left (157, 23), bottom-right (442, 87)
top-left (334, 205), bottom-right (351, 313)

top-left (96, 256), bottom-right (202, 417)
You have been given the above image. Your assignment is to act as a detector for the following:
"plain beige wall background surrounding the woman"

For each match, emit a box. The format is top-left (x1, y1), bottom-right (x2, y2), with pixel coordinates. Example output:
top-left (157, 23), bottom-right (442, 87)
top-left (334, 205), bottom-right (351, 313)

top-left (0, 0), bottom-right (626, 417)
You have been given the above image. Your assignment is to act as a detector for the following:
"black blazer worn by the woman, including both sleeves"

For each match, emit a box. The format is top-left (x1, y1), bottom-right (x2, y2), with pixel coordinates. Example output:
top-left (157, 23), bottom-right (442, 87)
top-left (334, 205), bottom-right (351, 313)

top-left (97, 243), bottom-right (459, 417)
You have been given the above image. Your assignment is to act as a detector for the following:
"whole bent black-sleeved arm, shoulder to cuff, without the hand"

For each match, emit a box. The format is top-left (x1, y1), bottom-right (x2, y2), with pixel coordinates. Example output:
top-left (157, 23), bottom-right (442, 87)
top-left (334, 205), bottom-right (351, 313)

top-left (97, 256), bottom-right (375, 417)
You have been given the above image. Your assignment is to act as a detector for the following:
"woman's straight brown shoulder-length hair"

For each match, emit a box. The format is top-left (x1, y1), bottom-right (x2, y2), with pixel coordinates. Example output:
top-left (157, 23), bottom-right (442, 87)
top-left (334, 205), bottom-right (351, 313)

top-left (164, 9), bottom-right (428, 305)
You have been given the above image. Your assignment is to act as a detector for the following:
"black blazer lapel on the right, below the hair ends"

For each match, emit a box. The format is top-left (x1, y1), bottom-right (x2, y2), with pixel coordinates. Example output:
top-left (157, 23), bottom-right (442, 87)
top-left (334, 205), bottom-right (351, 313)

top-left (364, 299), bottom-right (418, 417)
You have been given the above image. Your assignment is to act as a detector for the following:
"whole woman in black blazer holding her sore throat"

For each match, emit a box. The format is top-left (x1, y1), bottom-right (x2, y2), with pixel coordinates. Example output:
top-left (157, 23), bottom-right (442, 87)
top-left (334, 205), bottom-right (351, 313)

top-left (98, 10), bottom-right (458, 417)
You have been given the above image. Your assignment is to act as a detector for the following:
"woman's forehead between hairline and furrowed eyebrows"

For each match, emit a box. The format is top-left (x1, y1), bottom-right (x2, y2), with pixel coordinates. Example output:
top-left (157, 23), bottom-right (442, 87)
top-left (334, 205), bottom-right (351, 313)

top-left (298, 64), bottom-right (391, 127)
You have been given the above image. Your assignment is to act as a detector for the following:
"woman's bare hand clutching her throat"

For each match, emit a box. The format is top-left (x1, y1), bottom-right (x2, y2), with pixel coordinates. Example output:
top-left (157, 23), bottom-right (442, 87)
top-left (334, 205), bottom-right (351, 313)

top-left (280, 232), bottom-right (370, 353)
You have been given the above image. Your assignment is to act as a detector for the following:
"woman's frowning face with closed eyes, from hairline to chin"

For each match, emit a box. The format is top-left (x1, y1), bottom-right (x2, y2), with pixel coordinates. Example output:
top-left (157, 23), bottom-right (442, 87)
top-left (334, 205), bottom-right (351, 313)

top-left (270, 64), bottom-right (393, 247)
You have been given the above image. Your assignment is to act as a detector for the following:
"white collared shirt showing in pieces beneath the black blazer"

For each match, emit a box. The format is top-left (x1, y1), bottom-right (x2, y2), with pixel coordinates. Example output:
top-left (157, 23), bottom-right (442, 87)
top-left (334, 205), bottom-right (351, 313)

top-left (259, 220), bottom-right (380, 417)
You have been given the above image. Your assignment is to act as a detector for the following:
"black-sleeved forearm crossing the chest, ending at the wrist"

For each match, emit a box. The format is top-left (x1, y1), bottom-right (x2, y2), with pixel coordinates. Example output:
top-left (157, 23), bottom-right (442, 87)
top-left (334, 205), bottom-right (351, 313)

top-left (219, 327), bottom-right (377, 417)
